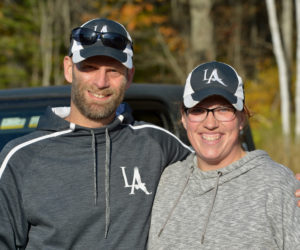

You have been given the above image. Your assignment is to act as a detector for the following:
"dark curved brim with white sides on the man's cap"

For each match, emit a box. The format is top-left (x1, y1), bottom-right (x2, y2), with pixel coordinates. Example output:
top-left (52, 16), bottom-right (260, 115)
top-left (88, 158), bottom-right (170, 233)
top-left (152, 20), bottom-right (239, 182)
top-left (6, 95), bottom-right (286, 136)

top-left (72, 46), bottom-right (133, 69)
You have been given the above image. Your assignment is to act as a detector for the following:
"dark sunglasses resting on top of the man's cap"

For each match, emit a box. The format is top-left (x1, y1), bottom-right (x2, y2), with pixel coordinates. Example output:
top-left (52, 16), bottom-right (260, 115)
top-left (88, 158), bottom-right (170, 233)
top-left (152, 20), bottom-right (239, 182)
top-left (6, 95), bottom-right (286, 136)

top-left (70, 27), bottom-right (132, 50)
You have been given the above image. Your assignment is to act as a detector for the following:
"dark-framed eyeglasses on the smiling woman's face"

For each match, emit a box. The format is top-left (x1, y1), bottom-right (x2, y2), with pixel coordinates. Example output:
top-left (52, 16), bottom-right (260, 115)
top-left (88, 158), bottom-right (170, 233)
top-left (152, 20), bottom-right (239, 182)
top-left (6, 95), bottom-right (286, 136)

top-left (185, 107), bottom-right (236, 122)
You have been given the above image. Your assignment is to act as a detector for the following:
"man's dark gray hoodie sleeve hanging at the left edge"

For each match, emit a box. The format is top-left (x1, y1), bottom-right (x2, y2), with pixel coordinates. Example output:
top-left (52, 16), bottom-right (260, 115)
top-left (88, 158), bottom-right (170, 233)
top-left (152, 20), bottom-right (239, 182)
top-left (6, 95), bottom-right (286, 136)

top-left (0, 147), bottom-right (28, 250)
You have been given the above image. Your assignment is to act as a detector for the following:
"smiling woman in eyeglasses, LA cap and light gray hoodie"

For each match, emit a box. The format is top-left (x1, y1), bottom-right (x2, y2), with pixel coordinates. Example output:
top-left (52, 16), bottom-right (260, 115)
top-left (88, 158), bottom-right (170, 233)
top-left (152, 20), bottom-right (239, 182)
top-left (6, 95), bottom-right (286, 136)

top-left (148, 62), bottom-right (300, 250)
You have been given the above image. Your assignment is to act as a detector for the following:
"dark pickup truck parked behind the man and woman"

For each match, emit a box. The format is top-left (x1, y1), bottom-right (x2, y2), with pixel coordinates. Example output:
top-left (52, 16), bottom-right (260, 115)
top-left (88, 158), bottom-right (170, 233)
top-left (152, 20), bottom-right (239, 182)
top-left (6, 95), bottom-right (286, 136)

top-left (0, 84), bottom-right (254, 151)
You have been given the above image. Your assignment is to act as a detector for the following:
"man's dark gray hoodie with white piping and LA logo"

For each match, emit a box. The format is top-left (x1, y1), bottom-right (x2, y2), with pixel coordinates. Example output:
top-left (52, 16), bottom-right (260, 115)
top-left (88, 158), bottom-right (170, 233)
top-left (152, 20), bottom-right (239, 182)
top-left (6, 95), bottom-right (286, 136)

top-left (0, 106), bottom-right (190, 250)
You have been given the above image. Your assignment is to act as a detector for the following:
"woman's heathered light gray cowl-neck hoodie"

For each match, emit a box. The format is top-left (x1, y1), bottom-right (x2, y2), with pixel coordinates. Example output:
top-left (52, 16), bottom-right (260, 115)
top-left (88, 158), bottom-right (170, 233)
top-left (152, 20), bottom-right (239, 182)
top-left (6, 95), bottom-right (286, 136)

top-left (148, 150), bottom-right (300, 250)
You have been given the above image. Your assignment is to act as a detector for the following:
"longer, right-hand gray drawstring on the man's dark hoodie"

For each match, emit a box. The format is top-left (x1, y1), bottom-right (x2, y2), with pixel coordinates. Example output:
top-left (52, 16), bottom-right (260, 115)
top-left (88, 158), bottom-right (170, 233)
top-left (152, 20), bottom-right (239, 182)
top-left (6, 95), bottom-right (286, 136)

top-left (104, 128), bottom-right (111, 239)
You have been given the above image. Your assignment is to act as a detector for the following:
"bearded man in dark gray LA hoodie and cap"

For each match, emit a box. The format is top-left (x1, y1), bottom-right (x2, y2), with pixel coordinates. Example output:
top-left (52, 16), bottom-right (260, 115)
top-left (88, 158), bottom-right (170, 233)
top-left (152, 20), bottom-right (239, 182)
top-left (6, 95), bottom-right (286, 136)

top-left (0, 19), bottom-right (190, 250)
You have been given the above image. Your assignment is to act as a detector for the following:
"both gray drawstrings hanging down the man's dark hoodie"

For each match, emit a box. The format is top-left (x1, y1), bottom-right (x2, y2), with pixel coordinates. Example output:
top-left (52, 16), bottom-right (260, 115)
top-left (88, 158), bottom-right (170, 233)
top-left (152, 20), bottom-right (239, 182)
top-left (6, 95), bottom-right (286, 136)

top-left (91, 128), bottom-right (111, 239)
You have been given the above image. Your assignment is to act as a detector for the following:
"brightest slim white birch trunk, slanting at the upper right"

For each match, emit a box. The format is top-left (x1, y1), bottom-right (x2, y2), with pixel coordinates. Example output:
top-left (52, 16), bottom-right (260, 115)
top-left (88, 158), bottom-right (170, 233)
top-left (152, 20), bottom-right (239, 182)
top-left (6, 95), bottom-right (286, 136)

top-left (266, 0), bottom-right (290, 144)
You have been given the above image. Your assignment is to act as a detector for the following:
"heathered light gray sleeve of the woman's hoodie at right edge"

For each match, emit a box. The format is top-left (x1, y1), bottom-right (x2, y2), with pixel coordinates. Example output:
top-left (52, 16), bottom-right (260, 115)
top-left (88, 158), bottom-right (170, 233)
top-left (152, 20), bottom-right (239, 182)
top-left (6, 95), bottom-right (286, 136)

top-left (267, 173), bottom-right (300, 249)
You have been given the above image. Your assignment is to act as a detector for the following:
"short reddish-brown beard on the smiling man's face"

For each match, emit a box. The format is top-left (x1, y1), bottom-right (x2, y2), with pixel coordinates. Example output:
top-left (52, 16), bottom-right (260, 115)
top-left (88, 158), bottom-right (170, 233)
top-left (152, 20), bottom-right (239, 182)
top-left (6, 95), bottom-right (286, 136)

top-left (71, 78), bottom-right (126, 121)
